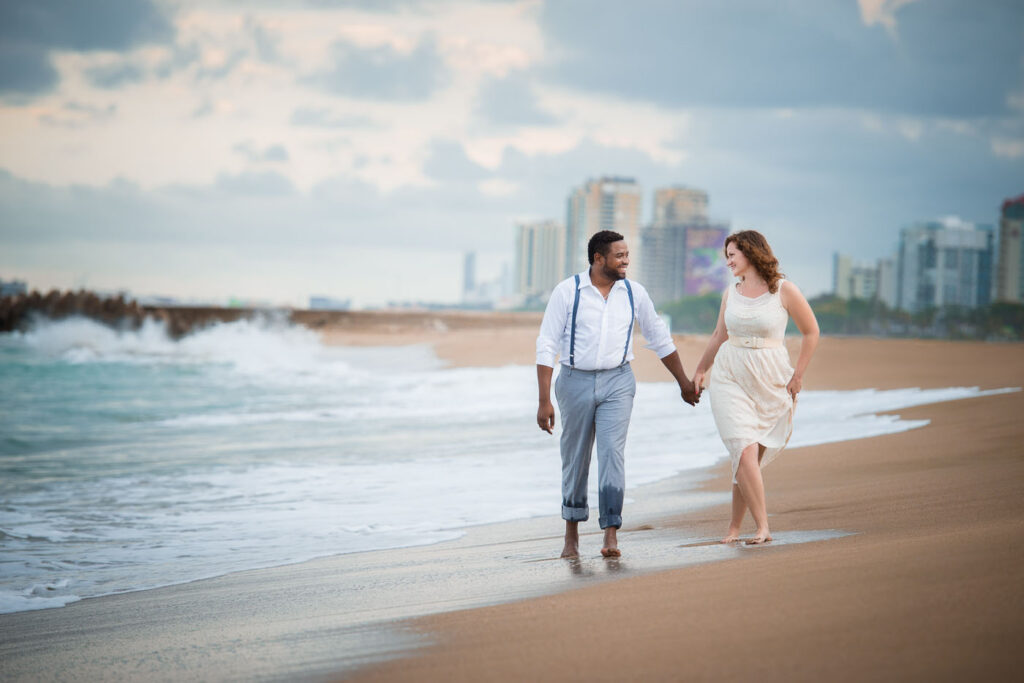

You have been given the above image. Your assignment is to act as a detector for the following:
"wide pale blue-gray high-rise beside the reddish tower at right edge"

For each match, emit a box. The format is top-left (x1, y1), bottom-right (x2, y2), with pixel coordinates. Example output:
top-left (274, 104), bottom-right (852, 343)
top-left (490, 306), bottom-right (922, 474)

top-left (896, 217), bottom-right (994, 312)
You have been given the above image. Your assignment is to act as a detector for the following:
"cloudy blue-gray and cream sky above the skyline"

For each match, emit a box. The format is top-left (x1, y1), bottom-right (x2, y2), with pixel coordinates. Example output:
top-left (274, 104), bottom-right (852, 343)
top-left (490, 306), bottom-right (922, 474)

top-left (0, 0), bottom-right (1024, 305)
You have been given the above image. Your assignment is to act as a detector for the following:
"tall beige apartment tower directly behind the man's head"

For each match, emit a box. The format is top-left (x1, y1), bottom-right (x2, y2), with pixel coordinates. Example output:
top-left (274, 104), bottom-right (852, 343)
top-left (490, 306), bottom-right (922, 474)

top-left (561, 176), bottom-right (643, 280)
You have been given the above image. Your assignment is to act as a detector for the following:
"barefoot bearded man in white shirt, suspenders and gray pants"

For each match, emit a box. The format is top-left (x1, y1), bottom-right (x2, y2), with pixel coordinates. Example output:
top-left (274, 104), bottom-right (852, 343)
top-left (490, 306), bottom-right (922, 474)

top-left (537, 230), bottom-right (699, 557)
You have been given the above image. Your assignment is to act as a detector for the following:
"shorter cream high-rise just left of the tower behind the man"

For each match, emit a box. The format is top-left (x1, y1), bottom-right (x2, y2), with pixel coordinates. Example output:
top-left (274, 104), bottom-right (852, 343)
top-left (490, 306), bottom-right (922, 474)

top-left (515, 220), bottom-right (565, 300)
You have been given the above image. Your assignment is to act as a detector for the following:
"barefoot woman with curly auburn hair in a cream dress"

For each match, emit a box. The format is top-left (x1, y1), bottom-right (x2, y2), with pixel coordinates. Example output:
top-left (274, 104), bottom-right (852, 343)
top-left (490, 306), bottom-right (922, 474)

top-left (693, 230), bottom-right (818, 545)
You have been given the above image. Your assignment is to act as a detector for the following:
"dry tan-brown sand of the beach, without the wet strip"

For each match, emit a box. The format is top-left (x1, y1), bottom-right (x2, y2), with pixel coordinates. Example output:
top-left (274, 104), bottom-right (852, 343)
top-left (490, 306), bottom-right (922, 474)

top-left (344, 321), bottom-right (1024, 681)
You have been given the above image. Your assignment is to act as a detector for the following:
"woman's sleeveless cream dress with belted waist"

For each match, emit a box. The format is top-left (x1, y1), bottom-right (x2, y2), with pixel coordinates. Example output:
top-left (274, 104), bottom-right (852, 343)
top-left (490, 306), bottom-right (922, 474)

top-left (709, 280), bottom-right (796, 483)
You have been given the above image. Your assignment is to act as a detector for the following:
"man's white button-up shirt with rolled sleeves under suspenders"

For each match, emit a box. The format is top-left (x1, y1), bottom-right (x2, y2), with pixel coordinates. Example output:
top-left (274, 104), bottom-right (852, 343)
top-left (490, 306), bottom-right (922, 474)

top-left (537, 268), bottom-right (676, 370)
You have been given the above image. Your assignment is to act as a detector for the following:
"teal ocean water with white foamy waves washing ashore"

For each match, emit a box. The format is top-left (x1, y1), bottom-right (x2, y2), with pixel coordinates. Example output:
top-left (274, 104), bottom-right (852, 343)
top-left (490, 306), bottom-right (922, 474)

top-left (0, 318), bottom-right (1015, 612)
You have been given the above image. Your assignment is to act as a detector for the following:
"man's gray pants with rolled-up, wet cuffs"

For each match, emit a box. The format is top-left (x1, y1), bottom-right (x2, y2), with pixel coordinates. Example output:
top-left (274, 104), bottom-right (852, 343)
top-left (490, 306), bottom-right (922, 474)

top-left (555, 364), bottom-right (637, 528)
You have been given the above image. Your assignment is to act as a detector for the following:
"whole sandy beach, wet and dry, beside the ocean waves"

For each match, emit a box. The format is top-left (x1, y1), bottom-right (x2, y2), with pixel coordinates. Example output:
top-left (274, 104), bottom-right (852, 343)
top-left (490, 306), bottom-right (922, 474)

top-left (0, 314), bottom-right (1024, 681)
